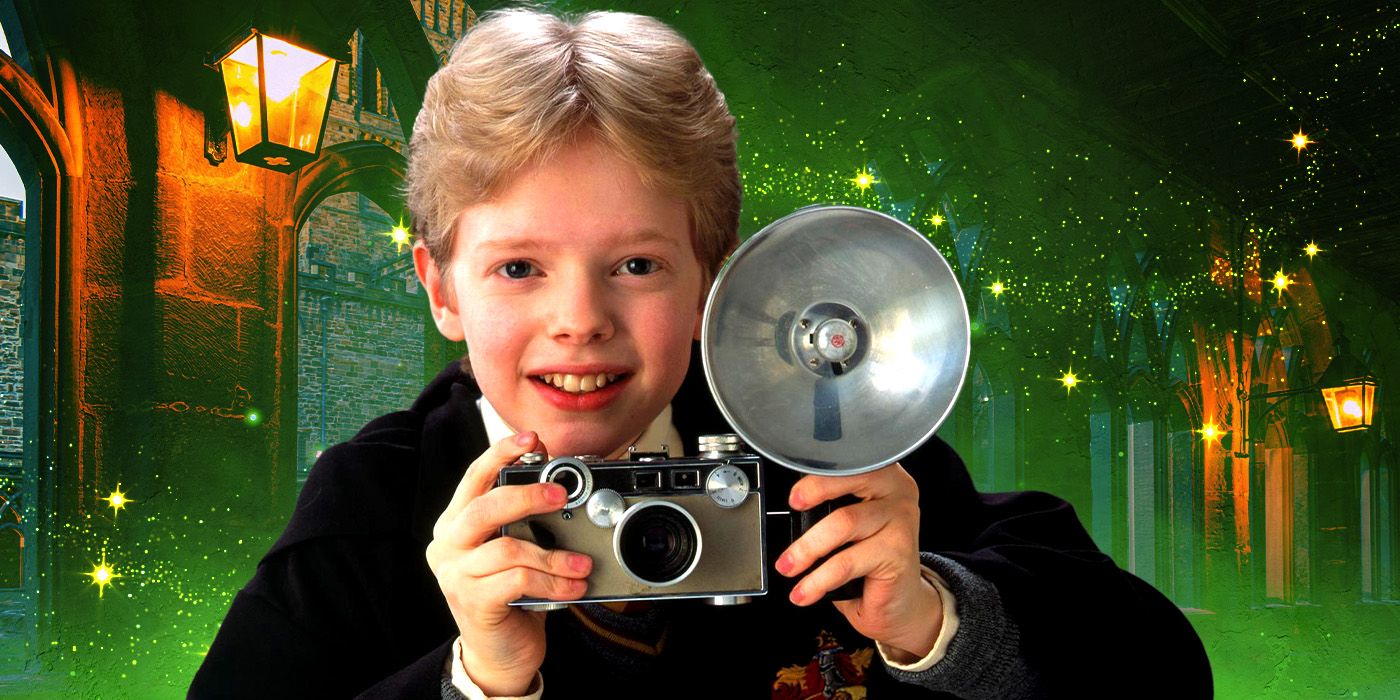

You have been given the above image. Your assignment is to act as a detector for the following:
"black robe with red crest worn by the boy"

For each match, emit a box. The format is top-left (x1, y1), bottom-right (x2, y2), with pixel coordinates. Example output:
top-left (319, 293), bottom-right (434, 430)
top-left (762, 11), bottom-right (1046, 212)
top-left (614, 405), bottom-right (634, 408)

top-left (189, 352), bottom-right (1211, 699)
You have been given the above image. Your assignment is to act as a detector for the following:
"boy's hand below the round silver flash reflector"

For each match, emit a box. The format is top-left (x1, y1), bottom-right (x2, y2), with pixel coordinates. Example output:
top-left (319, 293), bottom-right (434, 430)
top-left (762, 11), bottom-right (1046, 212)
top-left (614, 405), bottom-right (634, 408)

top-left (777, 463), bottom-right (944, 662)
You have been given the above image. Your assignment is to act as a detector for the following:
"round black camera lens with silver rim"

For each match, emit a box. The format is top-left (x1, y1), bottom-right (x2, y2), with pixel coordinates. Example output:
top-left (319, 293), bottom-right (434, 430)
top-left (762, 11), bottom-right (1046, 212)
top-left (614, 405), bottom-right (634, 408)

top-left (613, 501), bottom-right (700, 587)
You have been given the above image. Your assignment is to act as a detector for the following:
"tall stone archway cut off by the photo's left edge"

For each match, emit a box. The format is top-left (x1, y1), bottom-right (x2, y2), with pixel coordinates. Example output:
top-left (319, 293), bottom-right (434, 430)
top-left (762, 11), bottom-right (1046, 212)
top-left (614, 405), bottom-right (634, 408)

top-left (0, 9), bottom-right (83, 675)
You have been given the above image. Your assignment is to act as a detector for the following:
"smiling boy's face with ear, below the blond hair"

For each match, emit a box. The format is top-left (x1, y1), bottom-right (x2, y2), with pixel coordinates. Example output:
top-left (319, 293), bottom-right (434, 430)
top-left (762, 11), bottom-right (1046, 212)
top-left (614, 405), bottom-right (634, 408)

top-left (413, 139), bottom-right (704, 456)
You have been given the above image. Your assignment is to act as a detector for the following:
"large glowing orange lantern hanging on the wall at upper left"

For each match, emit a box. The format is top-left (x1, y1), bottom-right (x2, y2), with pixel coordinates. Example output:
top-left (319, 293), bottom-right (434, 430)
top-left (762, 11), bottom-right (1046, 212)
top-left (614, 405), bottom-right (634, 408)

top-left (210, 29), bottom-right (336, 172)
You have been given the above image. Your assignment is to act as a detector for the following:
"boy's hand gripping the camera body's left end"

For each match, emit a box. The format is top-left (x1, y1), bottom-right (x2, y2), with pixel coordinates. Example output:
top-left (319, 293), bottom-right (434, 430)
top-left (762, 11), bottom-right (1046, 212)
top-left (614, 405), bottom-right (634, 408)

top-left (427, 431), bottom-right (592, 696)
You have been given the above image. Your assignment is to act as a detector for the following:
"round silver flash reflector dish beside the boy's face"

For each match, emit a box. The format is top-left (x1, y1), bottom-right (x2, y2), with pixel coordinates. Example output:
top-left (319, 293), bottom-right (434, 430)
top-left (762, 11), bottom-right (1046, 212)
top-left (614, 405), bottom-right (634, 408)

top-left (701, 206), bottom-right (970, 475)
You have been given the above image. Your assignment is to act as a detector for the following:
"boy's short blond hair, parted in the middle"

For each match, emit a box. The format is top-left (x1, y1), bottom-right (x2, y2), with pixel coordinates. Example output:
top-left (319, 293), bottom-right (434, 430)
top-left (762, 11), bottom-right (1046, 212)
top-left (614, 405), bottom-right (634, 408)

top-left (407, 10), bottom-right (741, 287)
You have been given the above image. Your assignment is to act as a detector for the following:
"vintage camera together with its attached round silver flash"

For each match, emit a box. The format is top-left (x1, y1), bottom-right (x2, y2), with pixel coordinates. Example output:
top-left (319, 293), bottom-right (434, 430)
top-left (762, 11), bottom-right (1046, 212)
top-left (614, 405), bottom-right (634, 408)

top-left (498, 206), bottom-right (972, 609)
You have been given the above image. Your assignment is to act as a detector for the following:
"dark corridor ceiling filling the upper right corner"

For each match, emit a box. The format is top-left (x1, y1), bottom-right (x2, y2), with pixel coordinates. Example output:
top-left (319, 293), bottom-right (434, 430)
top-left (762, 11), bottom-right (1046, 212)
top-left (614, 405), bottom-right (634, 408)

top-left (957, 0), bottom-right (1400, 301)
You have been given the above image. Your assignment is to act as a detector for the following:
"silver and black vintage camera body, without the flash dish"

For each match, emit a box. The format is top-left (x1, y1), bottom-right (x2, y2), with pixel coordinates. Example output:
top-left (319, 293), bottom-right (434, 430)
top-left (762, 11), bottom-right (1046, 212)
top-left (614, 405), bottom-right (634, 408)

top-left (497, 434), bottom-right (769, 610)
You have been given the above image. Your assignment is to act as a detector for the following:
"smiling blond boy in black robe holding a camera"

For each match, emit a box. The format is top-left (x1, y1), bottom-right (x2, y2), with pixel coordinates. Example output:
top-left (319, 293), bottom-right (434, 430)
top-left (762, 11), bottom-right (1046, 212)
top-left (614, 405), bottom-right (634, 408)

top-left (190, 10), bottom-right (1211, 697)
